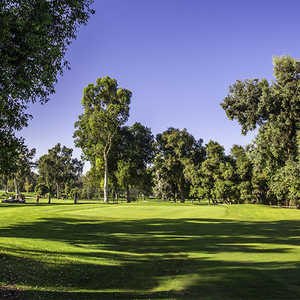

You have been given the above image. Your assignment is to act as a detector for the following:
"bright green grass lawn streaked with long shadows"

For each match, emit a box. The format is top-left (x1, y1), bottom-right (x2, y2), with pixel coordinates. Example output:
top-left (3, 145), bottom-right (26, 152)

top-left (0, 200), bottom-right (300, 300)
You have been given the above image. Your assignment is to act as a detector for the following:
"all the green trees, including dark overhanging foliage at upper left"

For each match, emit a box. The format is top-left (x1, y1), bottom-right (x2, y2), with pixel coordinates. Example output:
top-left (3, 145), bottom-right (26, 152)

top-left (0, 0), bottom-right (300, 206)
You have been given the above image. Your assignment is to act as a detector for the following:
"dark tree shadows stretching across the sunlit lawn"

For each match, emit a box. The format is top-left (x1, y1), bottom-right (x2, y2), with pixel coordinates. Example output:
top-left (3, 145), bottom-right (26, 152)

top-left (0, 218), bottom-right (300, 299)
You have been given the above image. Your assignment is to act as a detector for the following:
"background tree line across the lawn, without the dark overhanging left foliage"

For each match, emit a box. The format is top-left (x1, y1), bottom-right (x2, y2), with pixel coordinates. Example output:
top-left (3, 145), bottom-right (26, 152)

top-left (2, 57), bottom-right (300, 206)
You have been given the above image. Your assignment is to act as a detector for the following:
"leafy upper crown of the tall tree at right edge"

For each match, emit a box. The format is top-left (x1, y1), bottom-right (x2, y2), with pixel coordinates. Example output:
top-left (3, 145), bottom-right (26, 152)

top-left (221, 56), bottom-right (300, 162)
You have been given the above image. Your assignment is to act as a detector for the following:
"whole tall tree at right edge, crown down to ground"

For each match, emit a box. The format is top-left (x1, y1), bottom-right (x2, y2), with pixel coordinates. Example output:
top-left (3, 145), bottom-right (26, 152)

top-left (221, 56), bottom-right (300, 203)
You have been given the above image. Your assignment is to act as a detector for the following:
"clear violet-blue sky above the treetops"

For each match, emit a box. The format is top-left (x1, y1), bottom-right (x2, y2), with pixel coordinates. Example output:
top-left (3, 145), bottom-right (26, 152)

top-left (21, 0), bottom-right (300, 170)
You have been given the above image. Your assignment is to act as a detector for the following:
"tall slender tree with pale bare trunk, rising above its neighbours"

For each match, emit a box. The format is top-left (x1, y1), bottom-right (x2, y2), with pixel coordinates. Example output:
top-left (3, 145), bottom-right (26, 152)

top-left (74, 76), bottom-right (131, 202)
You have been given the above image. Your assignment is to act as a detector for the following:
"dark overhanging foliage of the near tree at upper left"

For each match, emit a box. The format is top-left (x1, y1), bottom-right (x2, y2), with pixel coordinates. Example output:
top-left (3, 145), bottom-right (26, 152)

top-left (0, 0), bottom-right (93, 171)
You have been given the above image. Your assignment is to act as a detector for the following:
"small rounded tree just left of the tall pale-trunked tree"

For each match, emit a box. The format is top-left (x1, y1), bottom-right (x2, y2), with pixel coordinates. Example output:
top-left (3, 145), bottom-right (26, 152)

top-left (38, 143), bottom-right (83, 203)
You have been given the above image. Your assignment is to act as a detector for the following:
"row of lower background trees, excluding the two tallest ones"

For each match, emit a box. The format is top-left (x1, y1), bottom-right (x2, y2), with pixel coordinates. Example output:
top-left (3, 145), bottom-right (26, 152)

top-left (0, 123), bottom-right (300, 206)
